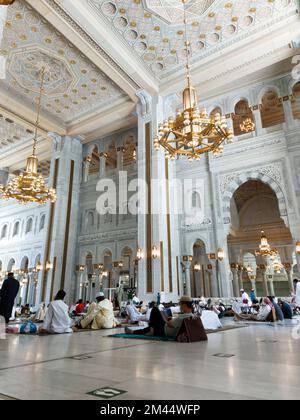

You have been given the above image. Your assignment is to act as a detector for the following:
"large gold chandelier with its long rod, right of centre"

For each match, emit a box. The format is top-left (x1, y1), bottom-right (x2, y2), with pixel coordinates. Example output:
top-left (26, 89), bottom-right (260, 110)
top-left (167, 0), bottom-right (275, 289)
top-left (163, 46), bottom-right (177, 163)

top-left (154, 0), bottom-right (234, 160)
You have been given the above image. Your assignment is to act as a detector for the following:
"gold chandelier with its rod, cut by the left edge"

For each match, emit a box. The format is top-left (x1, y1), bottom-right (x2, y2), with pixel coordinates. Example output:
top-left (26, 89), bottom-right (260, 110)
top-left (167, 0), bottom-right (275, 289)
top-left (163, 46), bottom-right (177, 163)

top-left (0, 67), bottom-right (56, 204)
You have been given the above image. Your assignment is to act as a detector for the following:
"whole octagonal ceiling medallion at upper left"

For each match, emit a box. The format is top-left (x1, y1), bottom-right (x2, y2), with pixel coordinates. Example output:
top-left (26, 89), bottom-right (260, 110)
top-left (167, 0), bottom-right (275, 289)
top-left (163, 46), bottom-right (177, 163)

top-left (8, 46), bottom-right (79, 97)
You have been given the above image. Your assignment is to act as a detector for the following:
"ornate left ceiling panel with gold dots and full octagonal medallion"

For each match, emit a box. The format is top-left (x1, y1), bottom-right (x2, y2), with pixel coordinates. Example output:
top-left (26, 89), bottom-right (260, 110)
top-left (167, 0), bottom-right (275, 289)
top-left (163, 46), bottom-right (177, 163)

top-left (0, 0), bottom-right (126, 124)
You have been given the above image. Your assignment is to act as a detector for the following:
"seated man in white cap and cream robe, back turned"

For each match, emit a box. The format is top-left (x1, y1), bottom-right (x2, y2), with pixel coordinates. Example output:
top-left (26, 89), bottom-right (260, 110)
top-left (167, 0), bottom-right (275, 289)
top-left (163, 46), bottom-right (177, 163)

top-left (74, 292), bottom-right (118, 331)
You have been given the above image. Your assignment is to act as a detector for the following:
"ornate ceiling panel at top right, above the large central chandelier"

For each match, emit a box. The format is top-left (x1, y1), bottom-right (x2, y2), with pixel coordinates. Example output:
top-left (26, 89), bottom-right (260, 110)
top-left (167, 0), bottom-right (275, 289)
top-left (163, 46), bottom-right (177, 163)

top-left (87, 0), bottom-right (297, 79)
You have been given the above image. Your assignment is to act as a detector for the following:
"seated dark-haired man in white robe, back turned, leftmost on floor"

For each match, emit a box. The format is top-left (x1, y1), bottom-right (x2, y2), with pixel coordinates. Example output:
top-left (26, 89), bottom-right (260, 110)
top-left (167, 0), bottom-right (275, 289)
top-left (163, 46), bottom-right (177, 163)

top-left (39, 290), bottom-right (73, 334)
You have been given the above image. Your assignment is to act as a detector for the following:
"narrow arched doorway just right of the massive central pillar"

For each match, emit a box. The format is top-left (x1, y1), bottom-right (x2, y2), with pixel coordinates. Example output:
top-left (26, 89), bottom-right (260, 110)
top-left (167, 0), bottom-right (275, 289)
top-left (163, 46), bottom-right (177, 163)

top-left (191, 239), bottom-right (212, 297)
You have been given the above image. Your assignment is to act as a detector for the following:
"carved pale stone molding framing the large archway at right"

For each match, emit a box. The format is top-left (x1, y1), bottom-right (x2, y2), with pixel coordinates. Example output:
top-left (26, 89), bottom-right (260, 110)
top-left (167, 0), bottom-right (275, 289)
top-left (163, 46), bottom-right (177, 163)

top-left (220, 165), bottom-right (289, 228)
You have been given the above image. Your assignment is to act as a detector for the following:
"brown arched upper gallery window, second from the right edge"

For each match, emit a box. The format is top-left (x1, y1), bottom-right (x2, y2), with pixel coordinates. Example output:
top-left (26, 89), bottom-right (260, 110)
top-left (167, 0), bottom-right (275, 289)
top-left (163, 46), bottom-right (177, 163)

top-left (260, 90), bottom-right (285, 128)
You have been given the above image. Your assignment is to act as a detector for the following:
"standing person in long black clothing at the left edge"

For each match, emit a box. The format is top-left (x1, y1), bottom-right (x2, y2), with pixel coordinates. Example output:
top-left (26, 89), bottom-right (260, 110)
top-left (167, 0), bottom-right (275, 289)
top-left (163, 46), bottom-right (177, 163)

top-left (0, 273), bottom-right (20, 324)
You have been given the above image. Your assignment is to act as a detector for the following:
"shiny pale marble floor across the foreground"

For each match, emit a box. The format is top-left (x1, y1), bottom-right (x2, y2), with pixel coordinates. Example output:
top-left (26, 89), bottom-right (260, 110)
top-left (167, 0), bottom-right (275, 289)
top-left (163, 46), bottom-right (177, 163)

top-left (0, 324), bottom-right (300, 400)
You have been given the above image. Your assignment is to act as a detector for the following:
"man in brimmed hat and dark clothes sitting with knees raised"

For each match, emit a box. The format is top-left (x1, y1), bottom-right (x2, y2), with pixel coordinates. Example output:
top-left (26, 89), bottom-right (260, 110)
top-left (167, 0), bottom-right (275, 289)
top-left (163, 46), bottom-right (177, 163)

top-left (125, 296), bottom-right (193, 339)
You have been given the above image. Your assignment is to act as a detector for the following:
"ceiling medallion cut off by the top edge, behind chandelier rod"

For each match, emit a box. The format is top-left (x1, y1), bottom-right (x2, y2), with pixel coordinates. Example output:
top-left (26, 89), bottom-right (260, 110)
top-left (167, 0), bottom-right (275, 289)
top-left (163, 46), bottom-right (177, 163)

top-left (144, 0), bottom-right (216, 24)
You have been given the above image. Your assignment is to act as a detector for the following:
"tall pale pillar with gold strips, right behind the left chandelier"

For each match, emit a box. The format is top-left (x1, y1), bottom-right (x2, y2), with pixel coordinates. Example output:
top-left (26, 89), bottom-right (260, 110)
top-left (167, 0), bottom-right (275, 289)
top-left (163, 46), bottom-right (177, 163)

top-left (41, 133), bottom-right (82, 303)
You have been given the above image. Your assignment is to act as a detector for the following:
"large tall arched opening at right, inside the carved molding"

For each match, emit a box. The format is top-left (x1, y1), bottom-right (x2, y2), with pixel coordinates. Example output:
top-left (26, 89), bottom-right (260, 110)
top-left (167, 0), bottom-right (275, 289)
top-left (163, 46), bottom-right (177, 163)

top-left (228, 179), bottom-right (293, 296)
